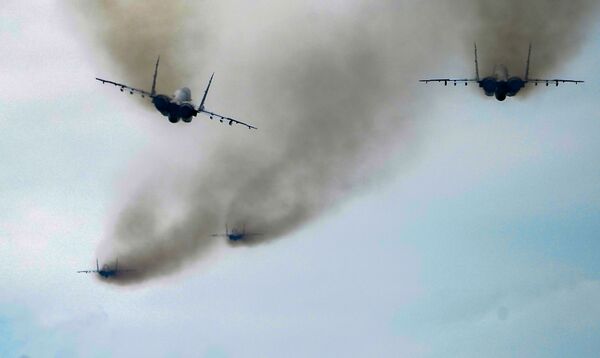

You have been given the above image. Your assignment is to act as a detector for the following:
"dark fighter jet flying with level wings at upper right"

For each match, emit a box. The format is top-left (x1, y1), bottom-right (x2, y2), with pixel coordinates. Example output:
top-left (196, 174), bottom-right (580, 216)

top-left (419, 44), bottom-right (583, 101)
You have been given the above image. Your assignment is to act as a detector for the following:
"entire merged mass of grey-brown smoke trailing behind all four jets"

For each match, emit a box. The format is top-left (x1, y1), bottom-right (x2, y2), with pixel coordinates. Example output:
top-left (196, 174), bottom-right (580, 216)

top-left (69, 0), bottom-right (595, 283)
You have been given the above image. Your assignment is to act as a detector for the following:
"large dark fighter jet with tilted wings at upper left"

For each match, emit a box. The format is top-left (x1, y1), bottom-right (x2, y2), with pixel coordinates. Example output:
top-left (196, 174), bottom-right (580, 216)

top-left (96, 56), bottom-right (257, 129)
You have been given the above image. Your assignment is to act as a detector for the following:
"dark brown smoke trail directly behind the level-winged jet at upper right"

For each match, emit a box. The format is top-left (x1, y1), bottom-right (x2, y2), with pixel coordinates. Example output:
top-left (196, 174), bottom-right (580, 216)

top-left (467, 0), bottom-right (598, 78)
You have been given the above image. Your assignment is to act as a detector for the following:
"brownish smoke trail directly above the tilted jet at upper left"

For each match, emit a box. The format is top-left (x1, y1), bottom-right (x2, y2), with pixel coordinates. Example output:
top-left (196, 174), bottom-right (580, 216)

top-left (72, 0), bottom-right (199, 96)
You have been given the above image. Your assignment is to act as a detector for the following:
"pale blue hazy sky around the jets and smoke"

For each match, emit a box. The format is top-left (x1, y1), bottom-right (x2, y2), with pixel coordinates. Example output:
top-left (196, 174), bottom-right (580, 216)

top-left (0, 0), bottom-right (600, 358)
